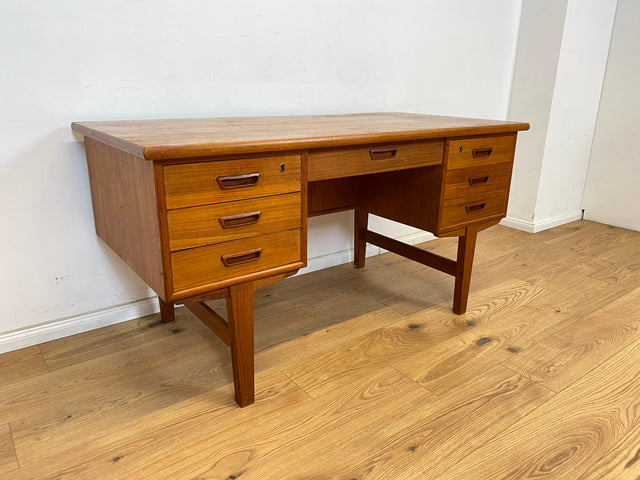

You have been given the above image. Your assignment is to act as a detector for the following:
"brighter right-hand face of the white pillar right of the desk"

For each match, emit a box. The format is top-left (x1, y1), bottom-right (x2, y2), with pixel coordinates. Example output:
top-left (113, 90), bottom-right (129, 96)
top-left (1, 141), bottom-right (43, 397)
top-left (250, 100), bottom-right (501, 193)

top-left (534, 0), bottom-right (617, 226)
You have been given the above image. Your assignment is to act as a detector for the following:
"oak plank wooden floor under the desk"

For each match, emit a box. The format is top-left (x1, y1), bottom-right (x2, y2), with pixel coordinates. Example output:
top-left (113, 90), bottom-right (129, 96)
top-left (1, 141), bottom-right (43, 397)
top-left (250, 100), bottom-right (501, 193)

top-left (0, 221), bottom-right (640, 480)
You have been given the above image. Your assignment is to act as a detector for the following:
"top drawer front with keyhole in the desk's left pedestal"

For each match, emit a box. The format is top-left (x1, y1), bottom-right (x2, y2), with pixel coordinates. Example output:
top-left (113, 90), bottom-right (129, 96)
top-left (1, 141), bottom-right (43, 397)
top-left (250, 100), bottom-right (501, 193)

top-left (163, 155), bottom-right (301, 210)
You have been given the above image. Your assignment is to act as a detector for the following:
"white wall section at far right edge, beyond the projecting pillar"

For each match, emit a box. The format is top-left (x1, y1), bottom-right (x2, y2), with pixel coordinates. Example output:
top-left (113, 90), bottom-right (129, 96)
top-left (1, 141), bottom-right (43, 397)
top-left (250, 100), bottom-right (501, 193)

top-left (582, 0), bottom-right (640, 231)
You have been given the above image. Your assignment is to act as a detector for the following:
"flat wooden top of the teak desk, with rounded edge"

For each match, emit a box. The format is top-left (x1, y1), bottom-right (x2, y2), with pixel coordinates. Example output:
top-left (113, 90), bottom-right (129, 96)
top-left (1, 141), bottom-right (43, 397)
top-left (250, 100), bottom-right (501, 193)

top-left (71, 113), bottom-right (529, 160)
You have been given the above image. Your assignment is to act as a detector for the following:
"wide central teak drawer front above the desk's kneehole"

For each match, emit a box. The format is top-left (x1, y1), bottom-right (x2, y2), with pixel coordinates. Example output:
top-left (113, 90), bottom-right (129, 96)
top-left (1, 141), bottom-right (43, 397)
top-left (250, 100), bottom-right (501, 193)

top-left (308, 139), bottom-right (444, 181)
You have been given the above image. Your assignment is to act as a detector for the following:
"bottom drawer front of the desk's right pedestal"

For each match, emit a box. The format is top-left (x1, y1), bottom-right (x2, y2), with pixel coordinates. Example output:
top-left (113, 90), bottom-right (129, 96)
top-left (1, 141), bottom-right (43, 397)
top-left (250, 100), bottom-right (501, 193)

top-left (440, 190), bottom-right (507, 230)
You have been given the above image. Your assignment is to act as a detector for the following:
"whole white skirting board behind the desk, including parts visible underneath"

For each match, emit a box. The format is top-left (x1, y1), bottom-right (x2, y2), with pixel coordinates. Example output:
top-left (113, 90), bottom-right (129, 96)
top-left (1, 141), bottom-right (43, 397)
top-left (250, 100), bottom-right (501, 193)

top-left (0, 232), bottom-right (435, 353)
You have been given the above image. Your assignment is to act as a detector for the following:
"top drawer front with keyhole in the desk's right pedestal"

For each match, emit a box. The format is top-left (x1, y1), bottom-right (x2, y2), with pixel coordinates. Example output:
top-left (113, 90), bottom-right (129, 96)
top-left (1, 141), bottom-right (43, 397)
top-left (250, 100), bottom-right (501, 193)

top-left (447, 134), bottom-right (516, 169)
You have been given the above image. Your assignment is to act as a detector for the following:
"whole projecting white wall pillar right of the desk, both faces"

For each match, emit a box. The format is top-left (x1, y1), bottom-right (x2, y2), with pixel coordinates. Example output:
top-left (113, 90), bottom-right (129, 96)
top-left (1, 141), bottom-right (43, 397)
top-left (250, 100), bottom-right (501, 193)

top-left (504, 0), bottom-right (617, 232)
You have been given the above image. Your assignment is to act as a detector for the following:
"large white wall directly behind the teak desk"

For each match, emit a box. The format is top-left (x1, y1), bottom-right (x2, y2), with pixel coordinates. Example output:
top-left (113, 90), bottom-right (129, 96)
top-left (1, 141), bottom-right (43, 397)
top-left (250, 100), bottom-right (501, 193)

top-left (0, 0), bottom-right (526, 349)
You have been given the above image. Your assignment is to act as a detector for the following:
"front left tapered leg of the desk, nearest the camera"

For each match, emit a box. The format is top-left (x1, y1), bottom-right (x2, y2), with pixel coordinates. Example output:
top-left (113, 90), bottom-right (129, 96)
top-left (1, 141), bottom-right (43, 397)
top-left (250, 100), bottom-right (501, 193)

top-left (227, 282), bottom-right (255, 407)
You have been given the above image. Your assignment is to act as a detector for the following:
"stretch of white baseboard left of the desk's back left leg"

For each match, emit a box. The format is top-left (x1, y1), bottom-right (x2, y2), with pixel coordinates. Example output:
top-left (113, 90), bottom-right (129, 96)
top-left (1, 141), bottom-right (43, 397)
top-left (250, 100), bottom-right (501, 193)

top-left (0, 297), bottom-right (160, 353)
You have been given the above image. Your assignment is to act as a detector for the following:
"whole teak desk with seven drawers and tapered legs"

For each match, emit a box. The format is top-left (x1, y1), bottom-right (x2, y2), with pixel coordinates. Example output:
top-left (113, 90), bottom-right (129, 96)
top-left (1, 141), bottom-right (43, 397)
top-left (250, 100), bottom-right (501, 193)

top-left (71, 113), bottom-right (529, 406)
